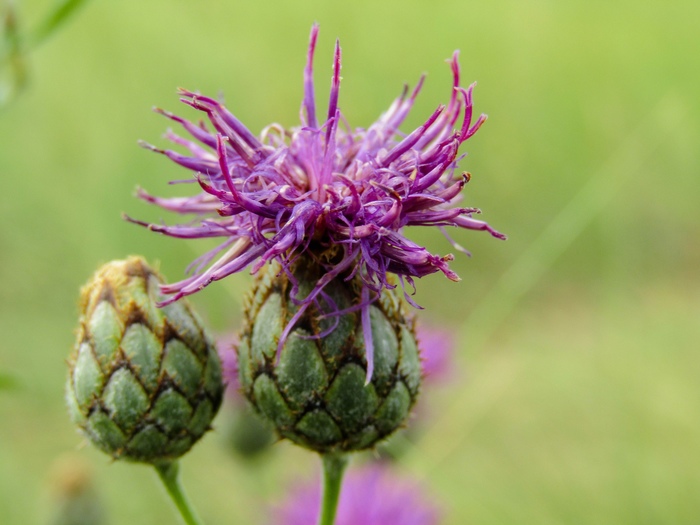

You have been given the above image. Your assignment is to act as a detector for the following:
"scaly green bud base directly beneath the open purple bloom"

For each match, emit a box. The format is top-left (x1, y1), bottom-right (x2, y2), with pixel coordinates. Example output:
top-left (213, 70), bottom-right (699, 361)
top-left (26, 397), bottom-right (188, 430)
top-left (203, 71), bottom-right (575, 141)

top-left (238, 256), bottom-right (421, 452)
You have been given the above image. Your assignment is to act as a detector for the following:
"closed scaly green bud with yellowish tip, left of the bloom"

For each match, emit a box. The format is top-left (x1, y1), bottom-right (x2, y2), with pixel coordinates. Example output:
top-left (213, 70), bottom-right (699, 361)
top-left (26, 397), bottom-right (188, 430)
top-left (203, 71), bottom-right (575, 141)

top-left (66, 257), bottom-right (223, 463)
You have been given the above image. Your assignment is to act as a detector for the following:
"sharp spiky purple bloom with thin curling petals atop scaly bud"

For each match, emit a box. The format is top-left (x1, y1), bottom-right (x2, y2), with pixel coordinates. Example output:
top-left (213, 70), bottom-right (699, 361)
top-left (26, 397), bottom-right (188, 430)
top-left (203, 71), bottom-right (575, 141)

top-left (127, 25), bottom-right (505, 377)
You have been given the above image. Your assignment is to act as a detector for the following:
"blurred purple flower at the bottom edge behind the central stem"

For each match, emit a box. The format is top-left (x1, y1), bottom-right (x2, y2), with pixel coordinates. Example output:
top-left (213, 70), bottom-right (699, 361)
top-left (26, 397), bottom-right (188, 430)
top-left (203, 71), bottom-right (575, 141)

top-left (271, 465), bottom-right (440, 525)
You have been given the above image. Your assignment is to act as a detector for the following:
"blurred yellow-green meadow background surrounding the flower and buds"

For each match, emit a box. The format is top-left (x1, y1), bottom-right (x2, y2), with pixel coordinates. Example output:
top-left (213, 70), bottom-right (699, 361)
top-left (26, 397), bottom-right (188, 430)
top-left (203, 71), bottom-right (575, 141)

top-left (0, 0), bottom-right (700, 525)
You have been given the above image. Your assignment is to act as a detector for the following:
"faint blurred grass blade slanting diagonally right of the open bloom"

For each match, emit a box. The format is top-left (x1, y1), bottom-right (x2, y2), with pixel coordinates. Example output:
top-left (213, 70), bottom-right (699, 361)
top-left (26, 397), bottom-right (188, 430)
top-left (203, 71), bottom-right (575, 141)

top-left (404, 93), bottom-right (685, 474)
